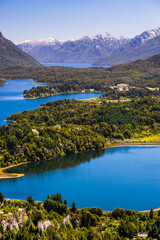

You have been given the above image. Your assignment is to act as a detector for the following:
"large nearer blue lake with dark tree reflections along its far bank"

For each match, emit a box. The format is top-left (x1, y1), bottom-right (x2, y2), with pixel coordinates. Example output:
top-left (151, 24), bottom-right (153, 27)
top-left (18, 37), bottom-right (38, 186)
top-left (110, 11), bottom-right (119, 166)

top-left (0, 146), bottom-right (160, 210)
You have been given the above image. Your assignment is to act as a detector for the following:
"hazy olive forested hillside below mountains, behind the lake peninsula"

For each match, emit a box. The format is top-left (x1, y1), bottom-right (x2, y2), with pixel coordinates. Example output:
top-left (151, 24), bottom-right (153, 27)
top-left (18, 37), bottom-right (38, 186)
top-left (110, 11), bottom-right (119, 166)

top-left (0, 55), bottom-right (160, 90)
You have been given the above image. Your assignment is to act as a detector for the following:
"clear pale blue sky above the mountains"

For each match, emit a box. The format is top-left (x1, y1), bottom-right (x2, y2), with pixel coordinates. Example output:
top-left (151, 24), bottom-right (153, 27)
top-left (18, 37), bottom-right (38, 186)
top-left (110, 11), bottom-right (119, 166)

top-left (0, 0), bottom-right (160, 42)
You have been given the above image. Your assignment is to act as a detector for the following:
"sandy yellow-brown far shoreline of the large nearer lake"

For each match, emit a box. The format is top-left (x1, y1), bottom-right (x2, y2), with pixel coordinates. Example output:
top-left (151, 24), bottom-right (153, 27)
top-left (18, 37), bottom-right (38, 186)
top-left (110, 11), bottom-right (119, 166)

top-left (0, 142), bottom-right (160, 180)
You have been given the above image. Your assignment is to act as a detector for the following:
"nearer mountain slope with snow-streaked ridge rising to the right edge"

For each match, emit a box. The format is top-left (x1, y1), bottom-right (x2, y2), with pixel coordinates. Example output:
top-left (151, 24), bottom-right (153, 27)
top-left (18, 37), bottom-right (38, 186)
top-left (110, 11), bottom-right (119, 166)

top-left (94, 26), bottom-right (160, 66)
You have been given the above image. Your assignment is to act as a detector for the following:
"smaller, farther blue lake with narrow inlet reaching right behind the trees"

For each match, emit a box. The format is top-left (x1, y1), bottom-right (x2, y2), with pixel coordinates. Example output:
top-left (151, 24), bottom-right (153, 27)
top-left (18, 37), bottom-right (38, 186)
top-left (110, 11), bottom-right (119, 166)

top-left (0, 79), bottom-right (101, 125)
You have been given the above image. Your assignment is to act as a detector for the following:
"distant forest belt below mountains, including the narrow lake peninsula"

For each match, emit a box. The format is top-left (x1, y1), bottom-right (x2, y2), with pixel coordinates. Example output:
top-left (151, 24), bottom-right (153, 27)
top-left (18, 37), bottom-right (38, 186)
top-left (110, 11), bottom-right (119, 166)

top-left (0, 55), bottom-right (160, 98)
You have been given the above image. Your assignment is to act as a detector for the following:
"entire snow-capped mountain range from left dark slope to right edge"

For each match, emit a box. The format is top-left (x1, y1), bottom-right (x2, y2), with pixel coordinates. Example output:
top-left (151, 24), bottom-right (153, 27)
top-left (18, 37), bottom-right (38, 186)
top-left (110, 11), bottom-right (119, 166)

top-left (16, 26), bottom-right (160, 66)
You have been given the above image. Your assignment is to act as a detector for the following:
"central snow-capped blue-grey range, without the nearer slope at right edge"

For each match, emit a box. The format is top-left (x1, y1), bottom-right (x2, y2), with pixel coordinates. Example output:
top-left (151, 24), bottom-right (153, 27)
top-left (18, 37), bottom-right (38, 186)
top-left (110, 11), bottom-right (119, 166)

top-left (16, 33), bottom-right (129, 63)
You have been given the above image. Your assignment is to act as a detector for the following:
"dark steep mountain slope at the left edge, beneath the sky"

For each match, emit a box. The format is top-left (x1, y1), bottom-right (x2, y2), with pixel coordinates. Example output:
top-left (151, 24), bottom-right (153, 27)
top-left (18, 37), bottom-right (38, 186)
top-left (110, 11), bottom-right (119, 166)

top-left (0, 32), bottom-right (41, 68)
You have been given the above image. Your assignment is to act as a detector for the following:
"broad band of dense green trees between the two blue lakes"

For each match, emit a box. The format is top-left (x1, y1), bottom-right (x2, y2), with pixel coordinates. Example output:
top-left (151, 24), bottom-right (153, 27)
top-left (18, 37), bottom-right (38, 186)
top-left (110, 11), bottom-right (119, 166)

top-left (0, 98), bottom-right (160, 167)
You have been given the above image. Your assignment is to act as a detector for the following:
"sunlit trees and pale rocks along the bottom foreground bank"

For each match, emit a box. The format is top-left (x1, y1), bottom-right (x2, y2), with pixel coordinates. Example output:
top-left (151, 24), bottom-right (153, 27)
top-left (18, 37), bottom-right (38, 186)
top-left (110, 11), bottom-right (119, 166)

top-left (0, 193), bottom-right (160, 240)
